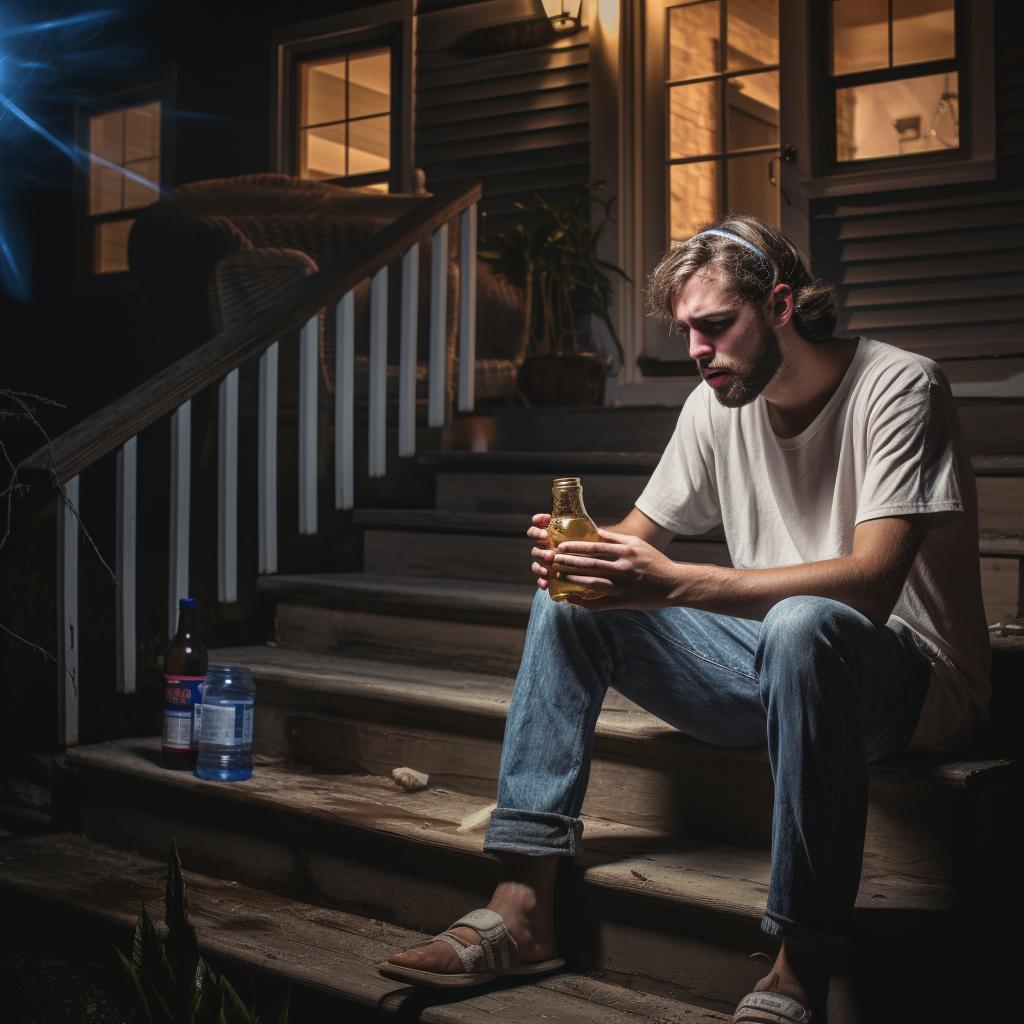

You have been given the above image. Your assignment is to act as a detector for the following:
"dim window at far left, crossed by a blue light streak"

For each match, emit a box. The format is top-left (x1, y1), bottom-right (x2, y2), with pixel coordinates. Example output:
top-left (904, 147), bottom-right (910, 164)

top-left (88, 102), bottom-right (160, 273)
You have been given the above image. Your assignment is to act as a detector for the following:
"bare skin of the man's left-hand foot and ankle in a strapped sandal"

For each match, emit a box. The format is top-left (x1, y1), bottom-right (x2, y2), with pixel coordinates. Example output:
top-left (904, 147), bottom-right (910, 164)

top-left (388, 855), bottom-right (558, 974)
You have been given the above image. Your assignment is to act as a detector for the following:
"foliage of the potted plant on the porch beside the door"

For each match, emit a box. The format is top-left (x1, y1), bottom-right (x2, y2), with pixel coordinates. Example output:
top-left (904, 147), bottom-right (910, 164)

top-left (479, 182), bottom-right (629, 362)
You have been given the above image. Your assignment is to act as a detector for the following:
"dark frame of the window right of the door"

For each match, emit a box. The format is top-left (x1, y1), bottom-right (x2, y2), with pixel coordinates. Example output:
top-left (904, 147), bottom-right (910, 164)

top-left (823, 0), bottom-right (974, 176)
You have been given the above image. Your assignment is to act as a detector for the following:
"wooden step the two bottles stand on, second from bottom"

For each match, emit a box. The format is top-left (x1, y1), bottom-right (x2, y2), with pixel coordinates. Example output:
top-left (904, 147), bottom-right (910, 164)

top-left (59, 737), bottom-right (957, 1024)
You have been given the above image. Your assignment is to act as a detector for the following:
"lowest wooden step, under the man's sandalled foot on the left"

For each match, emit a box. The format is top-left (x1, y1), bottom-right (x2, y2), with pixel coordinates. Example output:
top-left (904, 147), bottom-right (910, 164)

top-left (0, 833), bottom-right (730, 1024)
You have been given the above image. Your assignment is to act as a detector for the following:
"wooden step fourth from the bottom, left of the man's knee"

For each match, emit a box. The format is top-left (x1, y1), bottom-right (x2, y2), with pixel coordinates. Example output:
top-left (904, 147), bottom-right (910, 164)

top-left (256, 572), bottom-right (537, 676)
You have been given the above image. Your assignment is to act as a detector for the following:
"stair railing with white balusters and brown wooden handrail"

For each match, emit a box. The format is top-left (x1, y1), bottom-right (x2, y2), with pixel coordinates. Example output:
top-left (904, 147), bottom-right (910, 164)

top-left (22, 185), bottom-right (479, 745)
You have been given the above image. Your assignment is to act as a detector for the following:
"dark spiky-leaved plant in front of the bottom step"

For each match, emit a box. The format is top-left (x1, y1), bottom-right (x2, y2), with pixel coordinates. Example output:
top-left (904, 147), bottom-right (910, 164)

top-left (101, 845), bottom-right (289, 1024)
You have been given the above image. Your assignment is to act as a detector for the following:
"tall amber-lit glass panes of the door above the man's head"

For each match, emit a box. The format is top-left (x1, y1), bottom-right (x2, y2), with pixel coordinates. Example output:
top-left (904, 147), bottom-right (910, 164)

top-left (665, 0), bottom-right (779, 242)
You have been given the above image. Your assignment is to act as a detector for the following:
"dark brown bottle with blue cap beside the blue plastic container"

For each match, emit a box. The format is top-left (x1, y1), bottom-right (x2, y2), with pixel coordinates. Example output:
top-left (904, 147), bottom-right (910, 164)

top-left (160, 597), bottom-right (207, 771)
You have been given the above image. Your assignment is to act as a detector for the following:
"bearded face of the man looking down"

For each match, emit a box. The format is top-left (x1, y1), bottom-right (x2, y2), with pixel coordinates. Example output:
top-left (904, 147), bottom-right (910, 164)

top-left (675, 273), bottom-right (782, 409)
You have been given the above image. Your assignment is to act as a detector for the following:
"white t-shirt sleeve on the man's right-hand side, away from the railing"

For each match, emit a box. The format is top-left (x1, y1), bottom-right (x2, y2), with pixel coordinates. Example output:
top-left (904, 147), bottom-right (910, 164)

top-left (857, 380), bottom-right (964, 528)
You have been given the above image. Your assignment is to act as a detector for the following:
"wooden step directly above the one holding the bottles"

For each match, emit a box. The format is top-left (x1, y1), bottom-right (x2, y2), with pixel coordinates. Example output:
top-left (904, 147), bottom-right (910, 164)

top-left (211, 647), bottom-right (1017, 881)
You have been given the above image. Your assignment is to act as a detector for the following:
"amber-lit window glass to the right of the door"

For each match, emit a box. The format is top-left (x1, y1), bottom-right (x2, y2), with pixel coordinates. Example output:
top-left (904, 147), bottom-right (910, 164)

top-left (829, 0), bottom-right (961, 165)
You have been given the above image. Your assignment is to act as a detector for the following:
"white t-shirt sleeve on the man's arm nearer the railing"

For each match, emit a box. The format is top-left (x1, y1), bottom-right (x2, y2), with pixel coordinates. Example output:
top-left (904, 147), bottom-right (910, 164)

top-left (636, 387), bottom-right (722, 536)
